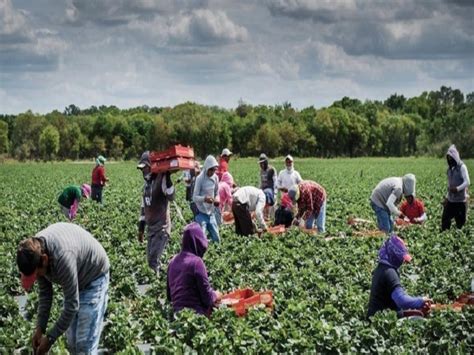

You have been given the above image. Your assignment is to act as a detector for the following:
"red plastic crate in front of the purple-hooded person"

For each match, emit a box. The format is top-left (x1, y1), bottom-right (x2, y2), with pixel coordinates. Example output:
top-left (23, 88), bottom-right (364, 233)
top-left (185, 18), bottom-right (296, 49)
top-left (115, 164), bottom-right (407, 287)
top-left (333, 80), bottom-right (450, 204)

top-left (221, 288), bottom-right (273, 317)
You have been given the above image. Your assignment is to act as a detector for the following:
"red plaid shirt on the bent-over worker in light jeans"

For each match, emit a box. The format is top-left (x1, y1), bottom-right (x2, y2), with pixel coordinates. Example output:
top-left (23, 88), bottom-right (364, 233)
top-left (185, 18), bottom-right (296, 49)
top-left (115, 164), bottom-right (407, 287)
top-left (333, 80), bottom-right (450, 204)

top-left (296, 180), bottom-right (326, 219)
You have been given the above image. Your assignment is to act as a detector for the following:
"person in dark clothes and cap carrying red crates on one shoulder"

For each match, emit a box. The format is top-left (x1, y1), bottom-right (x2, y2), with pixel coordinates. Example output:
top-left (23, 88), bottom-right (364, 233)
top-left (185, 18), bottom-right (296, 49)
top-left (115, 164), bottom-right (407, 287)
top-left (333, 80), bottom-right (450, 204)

top-left (137, 151), bottom-right (174, 276)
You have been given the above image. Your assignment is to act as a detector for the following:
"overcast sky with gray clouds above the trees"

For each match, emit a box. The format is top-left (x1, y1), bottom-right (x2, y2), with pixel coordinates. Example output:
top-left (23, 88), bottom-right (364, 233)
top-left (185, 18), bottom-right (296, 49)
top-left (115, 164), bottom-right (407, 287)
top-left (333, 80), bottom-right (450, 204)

top-left (0, 0), bottom-right (474, 113)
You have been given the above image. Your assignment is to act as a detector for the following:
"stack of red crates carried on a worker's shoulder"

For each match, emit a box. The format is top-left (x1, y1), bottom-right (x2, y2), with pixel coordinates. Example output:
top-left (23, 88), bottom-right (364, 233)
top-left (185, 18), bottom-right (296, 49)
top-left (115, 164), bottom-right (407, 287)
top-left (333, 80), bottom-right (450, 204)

top-left (150, 144), bottom-right (194, 174)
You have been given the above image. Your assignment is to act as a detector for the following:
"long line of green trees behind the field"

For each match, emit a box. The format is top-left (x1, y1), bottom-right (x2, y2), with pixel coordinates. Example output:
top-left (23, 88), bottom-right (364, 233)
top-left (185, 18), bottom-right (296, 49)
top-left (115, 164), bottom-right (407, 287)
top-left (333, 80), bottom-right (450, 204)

top-left (0, 86), bottom-right (474, 160)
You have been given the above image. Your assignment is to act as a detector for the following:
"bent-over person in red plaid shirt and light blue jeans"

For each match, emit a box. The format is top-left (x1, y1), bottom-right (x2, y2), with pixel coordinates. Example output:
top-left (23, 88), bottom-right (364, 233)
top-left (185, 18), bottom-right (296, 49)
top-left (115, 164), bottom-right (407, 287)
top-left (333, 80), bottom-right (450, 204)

top-left (288, 180), bottom-right (326, 233)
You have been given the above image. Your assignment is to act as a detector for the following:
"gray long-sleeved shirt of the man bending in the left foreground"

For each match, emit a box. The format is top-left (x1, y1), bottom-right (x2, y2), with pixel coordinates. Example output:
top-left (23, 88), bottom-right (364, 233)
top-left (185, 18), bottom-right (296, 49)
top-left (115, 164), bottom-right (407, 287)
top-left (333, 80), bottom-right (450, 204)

top-left (36, 223), bottom-right (109, 340)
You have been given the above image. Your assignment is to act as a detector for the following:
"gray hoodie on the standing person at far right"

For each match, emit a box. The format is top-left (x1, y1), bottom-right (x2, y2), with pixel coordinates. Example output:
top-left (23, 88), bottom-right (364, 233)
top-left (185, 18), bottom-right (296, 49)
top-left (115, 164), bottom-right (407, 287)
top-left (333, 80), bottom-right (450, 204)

top-left (446, 144), bottom-right (470, 202)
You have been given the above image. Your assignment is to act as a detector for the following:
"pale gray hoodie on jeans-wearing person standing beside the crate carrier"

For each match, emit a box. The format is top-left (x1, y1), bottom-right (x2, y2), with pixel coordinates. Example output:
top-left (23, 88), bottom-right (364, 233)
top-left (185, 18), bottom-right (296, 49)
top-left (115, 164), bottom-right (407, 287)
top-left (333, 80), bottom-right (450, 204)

top-left (193, 155), bottom-right (219, 215)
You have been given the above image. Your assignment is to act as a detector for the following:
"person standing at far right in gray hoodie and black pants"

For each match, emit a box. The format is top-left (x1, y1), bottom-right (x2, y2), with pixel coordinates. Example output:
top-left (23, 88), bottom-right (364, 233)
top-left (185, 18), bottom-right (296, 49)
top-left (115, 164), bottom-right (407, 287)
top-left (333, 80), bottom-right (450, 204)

top-left (441, 144), bottom-right (471, 231)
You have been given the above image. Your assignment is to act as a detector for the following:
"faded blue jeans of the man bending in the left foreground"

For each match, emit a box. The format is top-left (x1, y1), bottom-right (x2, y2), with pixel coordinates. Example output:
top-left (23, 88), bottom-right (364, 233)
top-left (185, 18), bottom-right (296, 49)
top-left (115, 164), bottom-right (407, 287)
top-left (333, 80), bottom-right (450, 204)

top-left (66, 272), bottom-right (109, 354)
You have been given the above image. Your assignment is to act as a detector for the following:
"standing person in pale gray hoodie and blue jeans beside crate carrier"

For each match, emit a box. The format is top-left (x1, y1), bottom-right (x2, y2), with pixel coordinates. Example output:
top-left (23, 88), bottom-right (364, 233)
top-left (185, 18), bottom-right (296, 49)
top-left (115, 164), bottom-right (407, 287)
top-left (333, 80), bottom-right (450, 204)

top-left (193, 155), bottom-right (219, 242)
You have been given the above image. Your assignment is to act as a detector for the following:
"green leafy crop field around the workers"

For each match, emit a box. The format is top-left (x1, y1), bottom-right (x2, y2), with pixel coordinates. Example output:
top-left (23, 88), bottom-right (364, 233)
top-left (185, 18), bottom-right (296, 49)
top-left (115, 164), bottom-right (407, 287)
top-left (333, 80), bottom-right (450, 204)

top-left (0, 158), bottom-right (474, 354)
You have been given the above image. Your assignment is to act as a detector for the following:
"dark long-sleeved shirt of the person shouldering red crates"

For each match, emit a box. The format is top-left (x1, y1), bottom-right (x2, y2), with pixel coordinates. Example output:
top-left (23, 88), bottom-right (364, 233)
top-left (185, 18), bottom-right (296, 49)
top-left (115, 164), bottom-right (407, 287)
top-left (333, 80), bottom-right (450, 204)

top-left (139, 174), bottom-right (174, 235)
